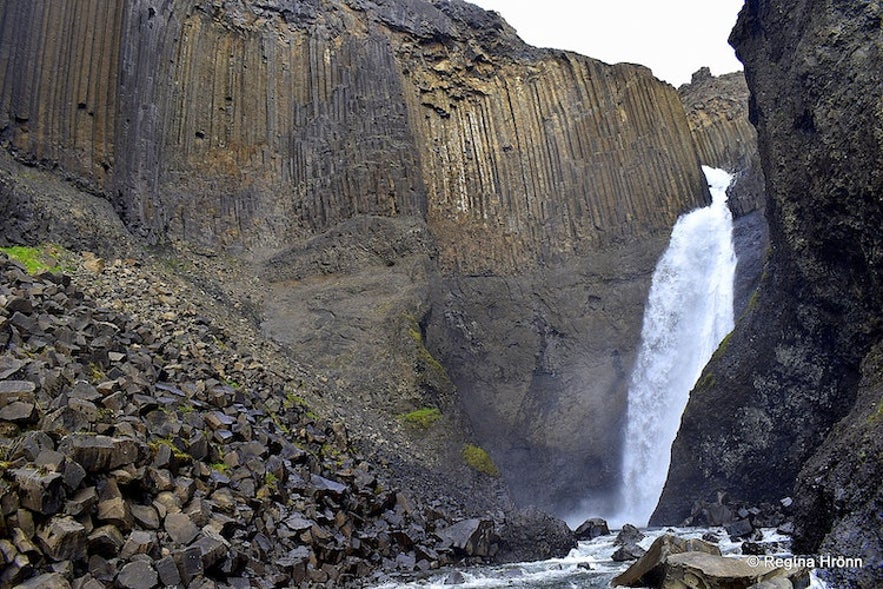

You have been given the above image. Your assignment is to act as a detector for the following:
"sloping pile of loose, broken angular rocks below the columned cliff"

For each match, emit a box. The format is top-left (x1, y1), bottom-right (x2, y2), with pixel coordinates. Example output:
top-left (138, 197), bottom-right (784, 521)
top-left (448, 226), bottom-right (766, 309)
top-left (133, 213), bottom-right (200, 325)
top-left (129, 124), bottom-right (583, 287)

top-left (0, 254), bottom-right (556, 589)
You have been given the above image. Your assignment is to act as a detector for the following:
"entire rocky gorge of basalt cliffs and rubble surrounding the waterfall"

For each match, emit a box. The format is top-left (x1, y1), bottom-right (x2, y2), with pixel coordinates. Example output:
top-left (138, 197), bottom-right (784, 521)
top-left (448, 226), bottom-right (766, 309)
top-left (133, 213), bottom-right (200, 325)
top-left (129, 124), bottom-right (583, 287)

top-left (0, 0), bottom-right (883, 589)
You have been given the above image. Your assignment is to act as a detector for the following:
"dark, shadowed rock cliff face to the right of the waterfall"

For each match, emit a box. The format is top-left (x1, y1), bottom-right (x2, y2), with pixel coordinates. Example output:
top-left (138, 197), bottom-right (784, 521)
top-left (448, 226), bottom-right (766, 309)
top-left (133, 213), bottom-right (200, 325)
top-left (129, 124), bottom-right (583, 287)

top-left (653, 0), bottom-right (883, 586)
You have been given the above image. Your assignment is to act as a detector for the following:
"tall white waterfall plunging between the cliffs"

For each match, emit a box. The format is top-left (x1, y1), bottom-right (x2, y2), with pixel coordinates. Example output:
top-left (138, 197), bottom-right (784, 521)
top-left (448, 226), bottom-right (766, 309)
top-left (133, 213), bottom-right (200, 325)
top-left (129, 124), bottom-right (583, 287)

top-left (611, 166), bottom-right (736, 526)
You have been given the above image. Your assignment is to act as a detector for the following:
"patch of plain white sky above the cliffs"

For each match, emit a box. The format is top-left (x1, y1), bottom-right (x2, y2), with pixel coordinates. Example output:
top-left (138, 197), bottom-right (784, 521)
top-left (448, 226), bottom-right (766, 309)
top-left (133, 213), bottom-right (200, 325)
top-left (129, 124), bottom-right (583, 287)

top-left (468, 0), bottom-right (743, 86)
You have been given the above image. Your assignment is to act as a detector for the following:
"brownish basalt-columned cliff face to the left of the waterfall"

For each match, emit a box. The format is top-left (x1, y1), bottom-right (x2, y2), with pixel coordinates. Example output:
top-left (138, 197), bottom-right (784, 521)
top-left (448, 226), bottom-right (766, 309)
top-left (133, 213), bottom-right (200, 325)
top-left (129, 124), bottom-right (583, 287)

top-left (0, 0), bottom-right (708, 510)
